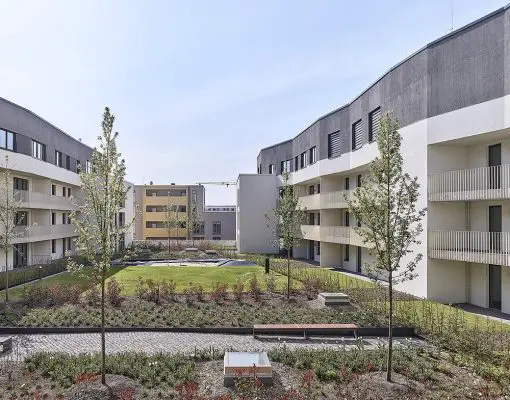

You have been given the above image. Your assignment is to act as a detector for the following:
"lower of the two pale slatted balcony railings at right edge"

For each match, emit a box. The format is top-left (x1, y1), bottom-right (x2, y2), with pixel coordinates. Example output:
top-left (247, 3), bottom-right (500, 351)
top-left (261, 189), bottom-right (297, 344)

top-left (428, 231), bottom-right (510, 266)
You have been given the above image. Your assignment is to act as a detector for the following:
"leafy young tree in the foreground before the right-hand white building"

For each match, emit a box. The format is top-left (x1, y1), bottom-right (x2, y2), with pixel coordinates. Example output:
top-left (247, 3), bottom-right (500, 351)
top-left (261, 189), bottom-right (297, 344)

top-left (348, 115), bottom-right (426, 381)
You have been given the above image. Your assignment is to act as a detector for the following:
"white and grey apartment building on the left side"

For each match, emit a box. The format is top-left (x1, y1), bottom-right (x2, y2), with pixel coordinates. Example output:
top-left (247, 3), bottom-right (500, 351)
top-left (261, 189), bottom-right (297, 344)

top-left (0, 98), bottom-right (133, 270)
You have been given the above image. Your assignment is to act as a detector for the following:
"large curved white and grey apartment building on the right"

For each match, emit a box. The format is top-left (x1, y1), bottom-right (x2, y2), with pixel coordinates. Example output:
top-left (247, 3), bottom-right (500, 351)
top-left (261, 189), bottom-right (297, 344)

top-left (237, 6), bottom-right (510, 313)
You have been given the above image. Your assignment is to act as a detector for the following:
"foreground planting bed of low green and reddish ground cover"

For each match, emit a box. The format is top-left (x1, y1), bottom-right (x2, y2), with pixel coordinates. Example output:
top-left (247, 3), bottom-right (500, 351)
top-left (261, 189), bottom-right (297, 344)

top-left (0, 340), bottom-right (507, 400)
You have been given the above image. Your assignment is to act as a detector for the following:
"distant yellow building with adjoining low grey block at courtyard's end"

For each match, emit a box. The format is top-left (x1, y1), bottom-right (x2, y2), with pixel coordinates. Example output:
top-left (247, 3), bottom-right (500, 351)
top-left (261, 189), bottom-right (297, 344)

top-left (135, 184), bottom-right (236, 241)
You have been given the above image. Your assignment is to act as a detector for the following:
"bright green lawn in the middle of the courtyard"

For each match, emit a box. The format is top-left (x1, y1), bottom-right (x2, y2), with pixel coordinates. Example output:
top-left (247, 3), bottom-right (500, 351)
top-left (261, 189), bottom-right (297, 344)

top-left (0, 266), bottom-right (292, 300)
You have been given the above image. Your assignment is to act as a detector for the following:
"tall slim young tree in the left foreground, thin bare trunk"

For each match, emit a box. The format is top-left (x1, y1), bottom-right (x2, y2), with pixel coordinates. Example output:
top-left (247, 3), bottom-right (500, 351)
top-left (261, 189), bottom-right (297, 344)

top-left (68, 107), bottom-right (133, 384)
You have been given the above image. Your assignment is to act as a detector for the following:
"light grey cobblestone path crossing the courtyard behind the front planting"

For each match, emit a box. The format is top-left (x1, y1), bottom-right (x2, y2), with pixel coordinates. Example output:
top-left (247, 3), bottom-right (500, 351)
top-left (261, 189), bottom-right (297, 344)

top-left (0, 332), bottom-right (423, 360)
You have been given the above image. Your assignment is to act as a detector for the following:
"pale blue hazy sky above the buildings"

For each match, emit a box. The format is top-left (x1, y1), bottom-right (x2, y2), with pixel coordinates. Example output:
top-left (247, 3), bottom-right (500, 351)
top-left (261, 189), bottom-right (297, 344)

top-left (0, 0), bottom-right (510, 204)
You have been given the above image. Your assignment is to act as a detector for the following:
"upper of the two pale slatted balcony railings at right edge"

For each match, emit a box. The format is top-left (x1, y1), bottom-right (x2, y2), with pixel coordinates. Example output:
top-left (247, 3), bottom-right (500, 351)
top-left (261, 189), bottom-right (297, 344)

top-left (428, 164), bottom-right (510, 201)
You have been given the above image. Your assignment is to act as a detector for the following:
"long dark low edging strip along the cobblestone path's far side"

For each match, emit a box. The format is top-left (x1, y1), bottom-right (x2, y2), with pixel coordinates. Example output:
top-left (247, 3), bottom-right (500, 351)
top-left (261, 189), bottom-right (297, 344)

top-left (0, 326), bottom-right (416, 337)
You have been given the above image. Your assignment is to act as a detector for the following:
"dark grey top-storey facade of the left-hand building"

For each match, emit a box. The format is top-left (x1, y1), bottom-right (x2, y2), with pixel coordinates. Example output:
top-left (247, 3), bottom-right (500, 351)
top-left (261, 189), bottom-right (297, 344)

top-left (0, 98), bottom-right (93, 172)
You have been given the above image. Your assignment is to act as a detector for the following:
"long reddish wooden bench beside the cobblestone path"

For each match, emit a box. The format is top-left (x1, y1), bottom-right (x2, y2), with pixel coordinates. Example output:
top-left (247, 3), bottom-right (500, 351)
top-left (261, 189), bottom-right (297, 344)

top-left (253, 324), bottom-right (359, 339)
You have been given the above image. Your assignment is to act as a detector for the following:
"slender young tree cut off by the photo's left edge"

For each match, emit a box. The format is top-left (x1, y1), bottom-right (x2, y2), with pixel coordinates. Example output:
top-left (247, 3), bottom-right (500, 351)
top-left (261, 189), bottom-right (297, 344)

top-left (0, 155), bottom-right (23, 303)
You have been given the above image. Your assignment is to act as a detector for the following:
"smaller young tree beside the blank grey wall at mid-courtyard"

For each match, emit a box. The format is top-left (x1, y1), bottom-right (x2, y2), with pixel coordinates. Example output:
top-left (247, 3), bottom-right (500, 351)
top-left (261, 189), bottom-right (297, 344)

top-left (266, 172), bottom-right (306, 299)
